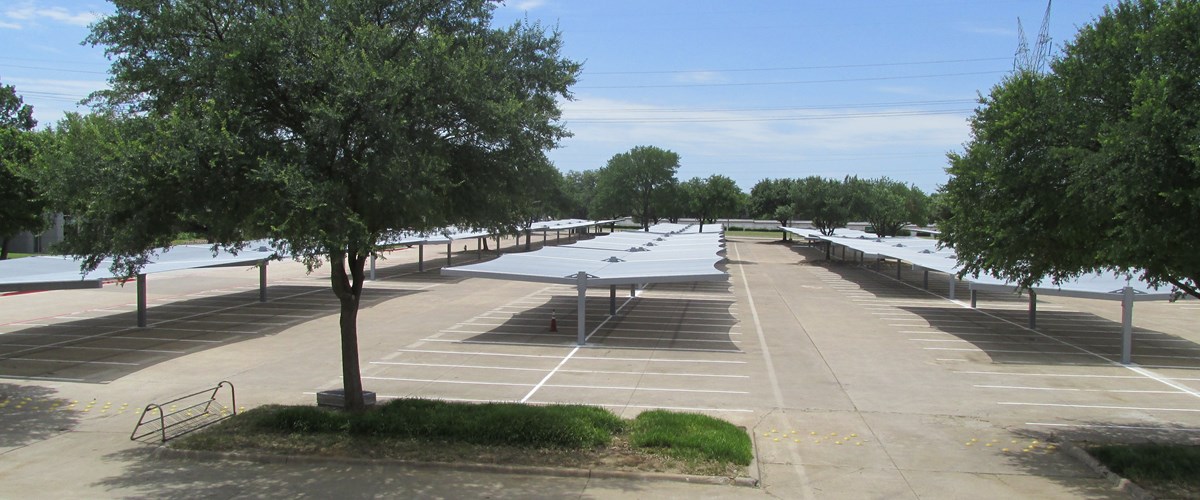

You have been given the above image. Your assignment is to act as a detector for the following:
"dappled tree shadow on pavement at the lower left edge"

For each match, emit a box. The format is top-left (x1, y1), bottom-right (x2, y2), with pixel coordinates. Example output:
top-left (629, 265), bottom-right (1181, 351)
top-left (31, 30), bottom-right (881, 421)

top-left (0, 382), bottom-right (79, 453)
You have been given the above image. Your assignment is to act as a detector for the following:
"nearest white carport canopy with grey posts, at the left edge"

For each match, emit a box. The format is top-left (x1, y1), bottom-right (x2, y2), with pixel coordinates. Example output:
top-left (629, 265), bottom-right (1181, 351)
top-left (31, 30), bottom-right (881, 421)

top-left (0, 245), bottom-right (275, 326)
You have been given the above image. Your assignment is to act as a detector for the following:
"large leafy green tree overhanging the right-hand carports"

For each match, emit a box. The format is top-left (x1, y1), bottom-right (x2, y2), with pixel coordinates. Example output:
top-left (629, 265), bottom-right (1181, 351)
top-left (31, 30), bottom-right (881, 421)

top-left (942, 0), bottom-right (1200, 296)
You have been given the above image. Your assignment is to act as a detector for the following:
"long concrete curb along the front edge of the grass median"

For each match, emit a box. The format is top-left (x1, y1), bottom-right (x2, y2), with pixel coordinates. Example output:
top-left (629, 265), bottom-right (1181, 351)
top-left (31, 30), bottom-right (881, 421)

top-left (150, 446), bottom-right (758, 488)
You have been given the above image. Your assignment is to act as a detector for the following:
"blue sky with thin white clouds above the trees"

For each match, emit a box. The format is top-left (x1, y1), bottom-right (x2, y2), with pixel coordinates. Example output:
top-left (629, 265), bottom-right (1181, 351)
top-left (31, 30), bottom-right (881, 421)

top-left (0, 0), bottom-right (1108, 192)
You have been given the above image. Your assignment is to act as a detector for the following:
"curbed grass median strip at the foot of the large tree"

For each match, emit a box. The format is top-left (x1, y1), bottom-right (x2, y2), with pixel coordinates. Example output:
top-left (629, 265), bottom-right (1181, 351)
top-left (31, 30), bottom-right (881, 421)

top-left (172, 399), bottom-right (752, 477)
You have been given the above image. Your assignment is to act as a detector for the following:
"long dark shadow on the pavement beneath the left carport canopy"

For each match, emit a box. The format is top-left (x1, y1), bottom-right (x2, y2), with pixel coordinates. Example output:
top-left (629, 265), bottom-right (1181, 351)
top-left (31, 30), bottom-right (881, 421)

top-left (0, 285), bottom-right (418, 384)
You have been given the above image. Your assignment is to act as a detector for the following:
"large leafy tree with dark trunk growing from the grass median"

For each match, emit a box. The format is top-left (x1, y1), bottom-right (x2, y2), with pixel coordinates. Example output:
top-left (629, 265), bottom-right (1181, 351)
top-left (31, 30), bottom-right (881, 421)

top-left (66, 0), bottom-right (580, 409)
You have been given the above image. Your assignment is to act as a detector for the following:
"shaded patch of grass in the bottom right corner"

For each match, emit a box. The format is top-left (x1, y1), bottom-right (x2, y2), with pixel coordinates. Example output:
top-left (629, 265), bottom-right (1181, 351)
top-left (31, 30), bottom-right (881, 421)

top-left (1087, 444), bottom-right (1200, 496)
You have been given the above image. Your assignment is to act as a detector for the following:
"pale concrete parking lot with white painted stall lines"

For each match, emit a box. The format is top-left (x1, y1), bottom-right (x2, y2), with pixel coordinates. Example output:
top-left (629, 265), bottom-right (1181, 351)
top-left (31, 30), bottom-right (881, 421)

top-left (0, 239), bottom-right (1200, 498)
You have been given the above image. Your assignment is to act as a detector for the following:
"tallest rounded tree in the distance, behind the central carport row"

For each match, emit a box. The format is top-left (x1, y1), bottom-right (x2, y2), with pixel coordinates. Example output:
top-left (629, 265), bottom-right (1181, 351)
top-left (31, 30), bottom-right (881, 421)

top-left (593, 146), bottom-right (679, 230)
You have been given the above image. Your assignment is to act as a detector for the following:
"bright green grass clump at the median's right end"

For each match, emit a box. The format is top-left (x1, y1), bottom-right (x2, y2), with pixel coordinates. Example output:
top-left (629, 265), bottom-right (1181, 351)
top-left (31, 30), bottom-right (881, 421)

top-left (629, 410), bottom-right (754, 465)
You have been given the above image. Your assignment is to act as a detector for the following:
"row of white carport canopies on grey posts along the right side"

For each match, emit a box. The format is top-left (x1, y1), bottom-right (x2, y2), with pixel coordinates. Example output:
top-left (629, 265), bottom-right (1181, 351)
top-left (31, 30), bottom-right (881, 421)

top-left (781, 228), bottom-right (1172, 365)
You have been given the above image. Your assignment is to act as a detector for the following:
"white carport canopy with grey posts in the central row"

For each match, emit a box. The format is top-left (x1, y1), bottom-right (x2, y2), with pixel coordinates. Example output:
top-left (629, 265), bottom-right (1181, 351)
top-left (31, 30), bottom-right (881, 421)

top-left (442, 225), bottom-right (728, 344)
